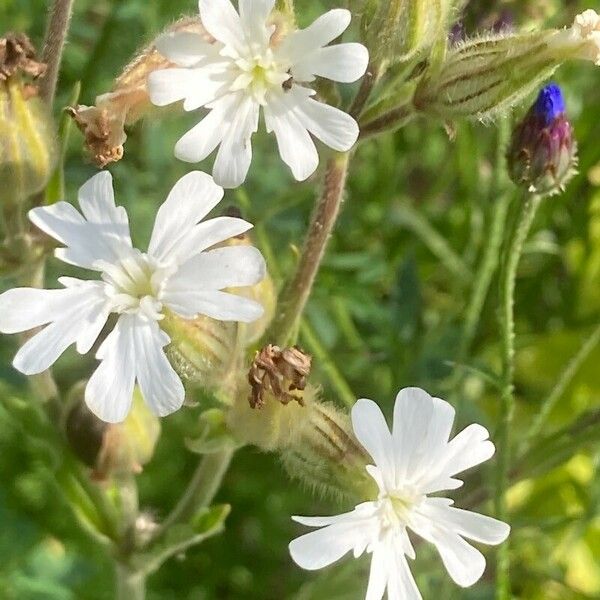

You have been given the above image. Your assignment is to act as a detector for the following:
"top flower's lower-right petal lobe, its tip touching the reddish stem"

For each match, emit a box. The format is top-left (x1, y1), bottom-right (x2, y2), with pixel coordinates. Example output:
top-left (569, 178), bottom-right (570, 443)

top-left (289, 86), bottom-right (359, 152)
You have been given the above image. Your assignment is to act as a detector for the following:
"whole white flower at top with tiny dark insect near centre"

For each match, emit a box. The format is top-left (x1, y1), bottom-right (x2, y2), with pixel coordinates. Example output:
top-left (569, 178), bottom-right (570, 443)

top-left (148, 0), bottom-right (369, 187)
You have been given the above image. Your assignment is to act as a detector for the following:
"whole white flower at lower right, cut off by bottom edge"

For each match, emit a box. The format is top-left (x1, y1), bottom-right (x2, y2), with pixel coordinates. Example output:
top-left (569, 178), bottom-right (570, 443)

top-left (290, 388), bottom-right (510, 600)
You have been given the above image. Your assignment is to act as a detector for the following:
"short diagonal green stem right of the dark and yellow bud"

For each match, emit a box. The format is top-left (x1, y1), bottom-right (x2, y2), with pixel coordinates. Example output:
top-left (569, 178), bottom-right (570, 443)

top-left (154, 449), bottom-right (233, 539)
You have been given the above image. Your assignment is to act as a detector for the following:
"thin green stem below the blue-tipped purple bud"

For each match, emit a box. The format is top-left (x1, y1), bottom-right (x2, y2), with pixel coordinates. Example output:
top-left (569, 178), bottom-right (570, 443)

top-left (495, 196), bottom-right (541, 600)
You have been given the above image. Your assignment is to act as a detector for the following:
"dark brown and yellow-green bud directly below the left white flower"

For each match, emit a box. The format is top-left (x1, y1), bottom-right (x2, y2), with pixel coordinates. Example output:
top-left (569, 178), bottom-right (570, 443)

top-left (65, 384), bottom-right (160, 480)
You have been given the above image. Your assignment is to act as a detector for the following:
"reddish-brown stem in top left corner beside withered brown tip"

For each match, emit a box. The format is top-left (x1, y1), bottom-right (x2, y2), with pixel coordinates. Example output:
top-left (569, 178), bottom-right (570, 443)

top-left (40, 0), bottom-right (74, 106)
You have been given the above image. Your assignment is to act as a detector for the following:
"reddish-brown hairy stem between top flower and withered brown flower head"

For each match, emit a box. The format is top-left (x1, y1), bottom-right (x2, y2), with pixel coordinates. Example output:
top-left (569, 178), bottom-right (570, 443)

top-left (267, 153), bottom-right (350, 346)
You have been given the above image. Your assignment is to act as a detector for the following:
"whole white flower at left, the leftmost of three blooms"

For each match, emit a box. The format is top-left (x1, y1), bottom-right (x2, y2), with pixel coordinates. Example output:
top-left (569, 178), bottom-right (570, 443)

top-left (0, 171), bottom-right (265, 422)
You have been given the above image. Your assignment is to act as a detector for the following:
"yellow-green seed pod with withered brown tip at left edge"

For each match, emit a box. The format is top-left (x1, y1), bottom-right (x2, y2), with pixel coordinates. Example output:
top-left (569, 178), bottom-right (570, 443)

top-left (0, 34), bottom-right (56, 206)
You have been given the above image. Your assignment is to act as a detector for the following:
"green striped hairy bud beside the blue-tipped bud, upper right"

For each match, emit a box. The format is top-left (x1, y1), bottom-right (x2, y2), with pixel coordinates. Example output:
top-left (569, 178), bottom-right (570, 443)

top-left (414, 11), bottom-right (600, 119)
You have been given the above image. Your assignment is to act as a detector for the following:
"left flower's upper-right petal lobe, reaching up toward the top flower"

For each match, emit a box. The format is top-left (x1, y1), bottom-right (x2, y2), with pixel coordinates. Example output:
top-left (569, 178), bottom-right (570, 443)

top-left (148, 171), bottom-right (223, 263)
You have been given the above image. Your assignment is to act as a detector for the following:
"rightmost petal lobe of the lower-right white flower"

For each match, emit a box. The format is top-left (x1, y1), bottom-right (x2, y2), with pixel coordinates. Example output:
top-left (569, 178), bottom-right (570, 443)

top-left (419, 498), bottom-right (510, 546)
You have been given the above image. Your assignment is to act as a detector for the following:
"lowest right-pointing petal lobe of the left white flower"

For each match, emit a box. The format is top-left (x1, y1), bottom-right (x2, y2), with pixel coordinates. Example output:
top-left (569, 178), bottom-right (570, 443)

top-left (164, 291), bottom-right (264, 323)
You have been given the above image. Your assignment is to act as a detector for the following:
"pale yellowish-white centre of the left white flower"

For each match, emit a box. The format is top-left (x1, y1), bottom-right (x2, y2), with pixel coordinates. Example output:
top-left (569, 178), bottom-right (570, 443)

top-left (99, 251), bottom-right (169, 320)
